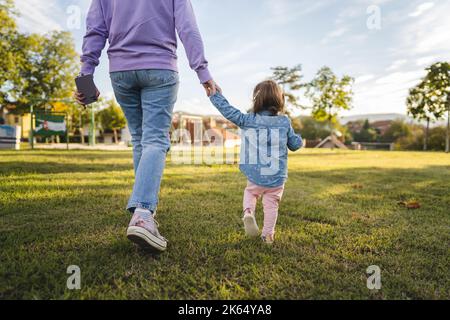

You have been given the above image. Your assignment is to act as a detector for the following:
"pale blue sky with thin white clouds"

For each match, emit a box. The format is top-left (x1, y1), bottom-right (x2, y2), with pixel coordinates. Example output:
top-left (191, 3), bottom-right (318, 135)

top-left (12, 0), bottom-right (450, 116)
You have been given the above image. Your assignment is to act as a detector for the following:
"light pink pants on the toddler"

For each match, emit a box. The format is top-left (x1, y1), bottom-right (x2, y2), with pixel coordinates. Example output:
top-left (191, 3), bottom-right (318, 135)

top-left (244, 181), bottom-right (284, 236)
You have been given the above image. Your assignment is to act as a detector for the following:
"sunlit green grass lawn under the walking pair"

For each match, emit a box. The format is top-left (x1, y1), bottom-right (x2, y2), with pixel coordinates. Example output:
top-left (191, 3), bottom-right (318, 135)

top-left (0, 150), bottom-right (450, 299)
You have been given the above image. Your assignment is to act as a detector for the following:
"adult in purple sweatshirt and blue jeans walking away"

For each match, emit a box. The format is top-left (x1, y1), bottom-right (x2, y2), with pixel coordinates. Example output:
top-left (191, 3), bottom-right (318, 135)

top-left (75, 0), bottom-right (217, 251)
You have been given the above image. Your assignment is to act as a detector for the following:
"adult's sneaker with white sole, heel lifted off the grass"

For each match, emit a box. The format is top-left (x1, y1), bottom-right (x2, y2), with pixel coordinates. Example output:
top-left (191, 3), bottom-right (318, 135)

top-left (127, 212), bottom-right (167, 252)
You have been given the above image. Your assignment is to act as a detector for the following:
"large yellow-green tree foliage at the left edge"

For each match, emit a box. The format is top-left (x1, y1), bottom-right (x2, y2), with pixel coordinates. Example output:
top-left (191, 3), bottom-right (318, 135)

top-left (0, 0), bottom-right (77, 113)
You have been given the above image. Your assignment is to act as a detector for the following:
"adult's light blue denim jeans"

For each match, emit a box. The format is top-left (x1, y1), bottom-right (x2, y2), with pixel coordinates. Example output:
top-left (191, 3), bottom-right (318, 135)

top-left (110, 70), bottom-right (179, 212)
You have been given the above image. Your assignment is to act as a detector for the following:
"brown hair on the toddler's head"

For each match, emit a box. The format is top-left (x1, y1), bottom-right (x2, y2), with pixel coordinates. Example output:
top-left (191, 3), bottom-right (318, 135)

top-left (253, 80), bottom-right (285, 116)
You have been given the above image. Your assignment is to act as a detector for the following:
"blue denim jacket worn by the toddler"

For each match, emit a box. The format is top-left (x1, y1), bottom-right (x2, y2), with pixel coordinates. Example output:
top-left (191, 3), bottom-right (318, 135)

top-left (210, 93), bottom-right (303, 188)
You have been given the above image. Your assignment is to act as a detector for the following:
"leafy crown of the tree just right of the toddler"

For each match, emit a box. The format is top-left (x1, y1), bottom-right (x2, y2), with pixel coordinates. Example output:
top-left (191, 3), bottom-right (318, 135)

top-left (306, 67), bottom-right (354, 128)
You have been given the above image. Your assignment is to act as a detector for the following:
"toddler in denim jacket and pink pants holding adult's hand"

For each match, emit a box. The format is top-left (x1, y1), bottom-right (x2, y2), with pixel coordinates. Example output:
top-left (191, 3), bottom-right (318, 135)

top-left (210, 80), bottom-right (303, 244)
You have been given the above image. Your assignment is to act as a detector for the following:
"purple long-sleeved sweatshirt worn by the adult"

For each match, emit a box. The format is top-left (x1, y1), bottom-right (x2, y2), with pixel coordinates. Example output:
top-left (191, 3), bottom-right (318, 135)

top-left (81, 0), bottom-right (212, 83)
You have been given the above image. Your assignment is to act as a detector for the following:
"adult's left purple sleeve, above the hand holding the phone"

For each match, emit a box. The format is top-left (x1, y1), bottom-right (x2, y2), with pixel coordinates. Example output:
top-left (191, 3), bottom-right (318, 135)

top-left (81, 0), bottom-right (109, 75)
